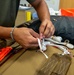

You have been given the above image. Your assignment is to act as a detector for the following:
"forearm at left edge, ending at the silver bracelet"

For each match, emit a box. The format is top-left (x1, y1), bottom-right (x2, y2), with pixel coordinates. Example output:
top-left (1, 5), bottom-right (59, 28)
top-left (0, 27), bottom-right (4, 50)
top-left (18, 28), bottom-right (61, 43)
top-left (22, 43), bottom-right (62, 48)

top-left (0, 26), bottom-right (12, 39)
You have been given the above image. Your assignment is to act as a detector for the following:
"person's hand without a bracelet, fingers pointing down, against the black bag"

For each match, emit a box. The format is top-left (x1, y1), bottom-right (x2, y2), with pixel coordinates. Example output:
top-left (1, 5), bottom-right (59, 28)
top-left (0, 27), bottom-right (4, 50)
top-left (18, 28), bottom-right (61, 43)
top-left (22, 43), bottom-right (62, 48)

top-left (39, 19), bottom-right (55, 38)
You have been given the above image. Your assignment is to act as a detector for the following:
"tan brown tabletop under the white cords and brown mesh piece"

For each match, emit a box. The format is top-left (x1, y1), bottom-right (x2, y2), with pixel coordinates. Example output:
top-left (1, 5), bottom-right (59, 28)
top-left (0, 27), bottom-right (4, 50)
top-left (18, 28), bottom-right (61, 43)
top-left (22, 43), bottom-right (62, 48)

top-left (0, 47), bottom-right (74, 75)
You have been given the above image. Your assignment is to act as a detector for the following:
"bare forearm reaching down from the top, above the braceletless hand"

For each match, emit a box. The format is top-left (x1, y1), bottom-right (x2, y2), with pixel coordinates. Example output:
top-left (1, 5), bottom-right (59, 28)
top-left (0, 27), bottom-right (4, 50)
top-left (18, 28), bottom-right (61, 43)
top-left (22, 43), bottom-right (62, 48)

top-left (32, 0), bottom-right (50, 21)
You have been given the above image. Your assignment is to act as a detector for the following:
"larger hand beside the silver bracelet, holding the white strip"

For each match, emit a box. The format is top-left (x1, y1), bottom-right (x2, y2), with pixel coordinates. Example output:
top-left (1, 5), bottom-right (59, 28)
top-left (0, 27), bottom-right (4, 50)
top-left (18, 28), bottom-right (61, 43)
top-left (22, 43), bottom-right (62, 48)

top-left (13, 27), bottom-right (39, 49)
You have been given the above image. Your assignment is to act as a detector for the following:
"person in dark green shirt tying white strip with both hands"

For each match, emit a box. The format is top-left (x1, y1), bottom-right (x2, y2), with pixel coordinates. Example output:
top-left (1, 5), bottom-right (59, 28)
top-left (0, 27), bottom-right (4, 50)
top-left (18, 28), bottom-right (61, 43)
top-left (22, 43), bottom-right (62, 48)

top-left (0, 0), bottom-right (55, 48)
